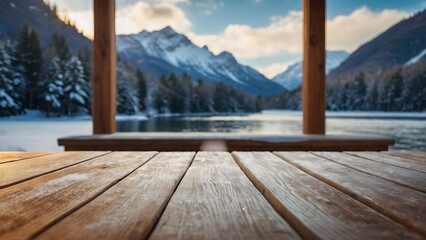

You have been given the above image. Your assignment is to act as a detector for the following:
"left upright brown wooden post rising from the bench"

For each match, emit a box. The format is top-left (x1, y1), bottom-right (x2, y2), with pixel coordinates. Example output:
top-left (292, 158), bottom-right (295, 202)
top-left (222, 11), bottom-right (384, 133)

top-left (92, 0), bottom-right (117, 134)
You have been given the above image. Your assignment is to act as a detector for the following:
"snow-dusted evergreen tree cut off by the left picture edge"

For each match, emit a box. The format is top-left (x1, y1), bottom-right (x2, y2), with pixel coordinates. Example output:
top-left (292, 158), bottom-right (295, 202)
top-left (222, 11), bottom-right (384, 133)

top-left (0, 47), bottom-right (20, 116)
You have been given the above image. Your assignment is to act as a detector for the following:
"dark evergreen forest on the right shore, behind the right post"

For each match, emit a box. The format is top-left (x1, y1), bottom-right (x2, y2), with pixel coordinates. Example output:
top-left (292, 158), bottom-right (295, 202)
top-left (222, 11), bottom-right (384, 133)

top-left (263, 59), bottom-right (426, 112)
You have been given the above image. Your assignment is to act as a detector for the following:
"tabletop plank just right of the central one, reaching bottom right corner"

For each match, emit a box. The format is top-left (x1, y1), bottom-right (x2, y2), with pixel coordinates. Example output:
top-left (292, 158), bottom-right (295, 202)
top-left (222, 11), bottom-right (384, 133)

top-left (233, 152), bottom-right (422, 239)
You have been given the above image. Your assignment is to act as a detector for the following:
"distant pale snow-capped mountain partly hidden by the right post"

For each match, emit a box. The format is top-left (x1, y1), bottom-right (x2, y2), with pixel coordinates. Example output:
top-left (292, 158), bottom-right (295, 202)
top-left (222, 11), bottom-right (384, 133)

top-left (272, 51), bottom-right (349, 90)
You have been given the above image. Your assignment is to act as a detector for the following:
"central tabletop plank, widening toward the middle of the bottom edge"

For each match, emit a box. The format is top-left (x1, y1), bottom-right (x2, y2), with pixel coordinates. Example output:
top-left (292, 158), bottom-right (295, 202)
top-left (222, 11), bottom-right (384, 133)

top-left (150, 152), bottom-right (299, 239)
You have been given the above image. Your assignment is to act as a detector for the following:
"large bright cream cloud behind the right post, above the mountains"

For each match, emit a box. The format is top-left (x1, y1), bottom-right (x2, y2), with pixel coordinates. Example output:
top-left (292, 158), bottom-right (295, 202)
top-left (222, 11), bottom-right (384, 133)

top-left (188, 7), bottom-right (409, 59)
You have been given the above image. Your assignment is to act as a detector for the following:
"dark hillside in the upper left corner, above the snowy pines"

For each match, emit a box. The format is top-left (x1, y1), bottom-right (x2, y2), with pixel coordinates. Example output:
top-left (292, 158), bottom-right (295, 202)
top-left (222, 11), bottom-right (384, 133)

top-left (0, 0), bottom-right (91, 52)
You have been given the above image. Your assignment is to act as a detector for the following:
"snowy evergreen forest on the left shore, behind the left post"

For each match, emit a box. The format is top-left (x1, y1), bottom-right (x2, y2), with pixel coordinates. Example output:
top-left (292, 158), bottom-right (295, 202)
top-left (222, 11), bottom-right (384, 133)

top-left (0, 25), bottom-right (260, 117)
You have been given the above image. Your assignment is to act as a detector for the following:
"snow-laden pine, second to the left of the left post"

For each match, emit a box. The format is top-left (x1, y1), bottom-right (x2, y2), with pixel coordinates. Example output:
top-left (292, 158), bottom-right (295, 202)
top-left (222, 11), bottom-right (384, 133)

top-left (40, 57), bottom-right (64, 117)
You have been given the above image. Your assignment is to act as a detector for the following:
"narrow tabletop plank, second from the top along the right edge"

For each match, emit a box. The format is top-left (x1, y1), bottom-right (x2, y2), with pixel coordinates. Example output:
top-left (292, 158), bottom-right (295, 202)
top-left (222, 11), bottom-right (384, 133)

top-left (348, 152), bottom-right (426, 173)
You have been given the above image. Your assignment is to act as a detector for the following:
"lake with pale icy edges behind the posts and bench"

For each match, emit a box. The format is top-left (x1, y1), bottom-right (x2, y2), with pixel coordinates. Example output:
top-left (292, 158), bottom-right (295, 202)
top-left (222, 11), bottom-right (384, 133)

top-left (0, 111), bottom-right (426, 151)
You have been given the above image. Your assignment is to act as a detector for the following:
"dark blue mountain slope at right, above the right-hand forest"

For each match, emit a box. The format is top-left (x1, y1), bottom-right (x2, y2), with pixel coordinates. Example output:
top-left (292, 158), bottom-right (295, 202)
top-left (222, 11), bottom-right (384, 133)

top-left (329, 10), bottom-right (426, 80)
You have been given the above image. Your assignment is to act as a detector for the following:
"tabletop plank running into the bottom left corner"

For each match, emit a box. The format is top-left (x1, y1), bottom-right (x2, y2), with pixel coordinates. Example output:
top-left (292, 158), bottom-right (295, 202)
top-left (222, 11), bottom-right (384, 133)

top-left (0, 152), bottom-right (155, 239)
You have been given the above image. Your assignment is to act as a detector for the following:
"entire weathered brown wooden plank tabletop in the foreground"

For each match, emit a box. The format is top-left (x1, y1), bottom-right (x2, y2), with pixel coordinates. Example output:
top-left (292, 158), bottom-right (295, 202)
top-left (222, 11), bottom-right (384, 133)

top-left (0, 152), bottom-right (426, 239)
